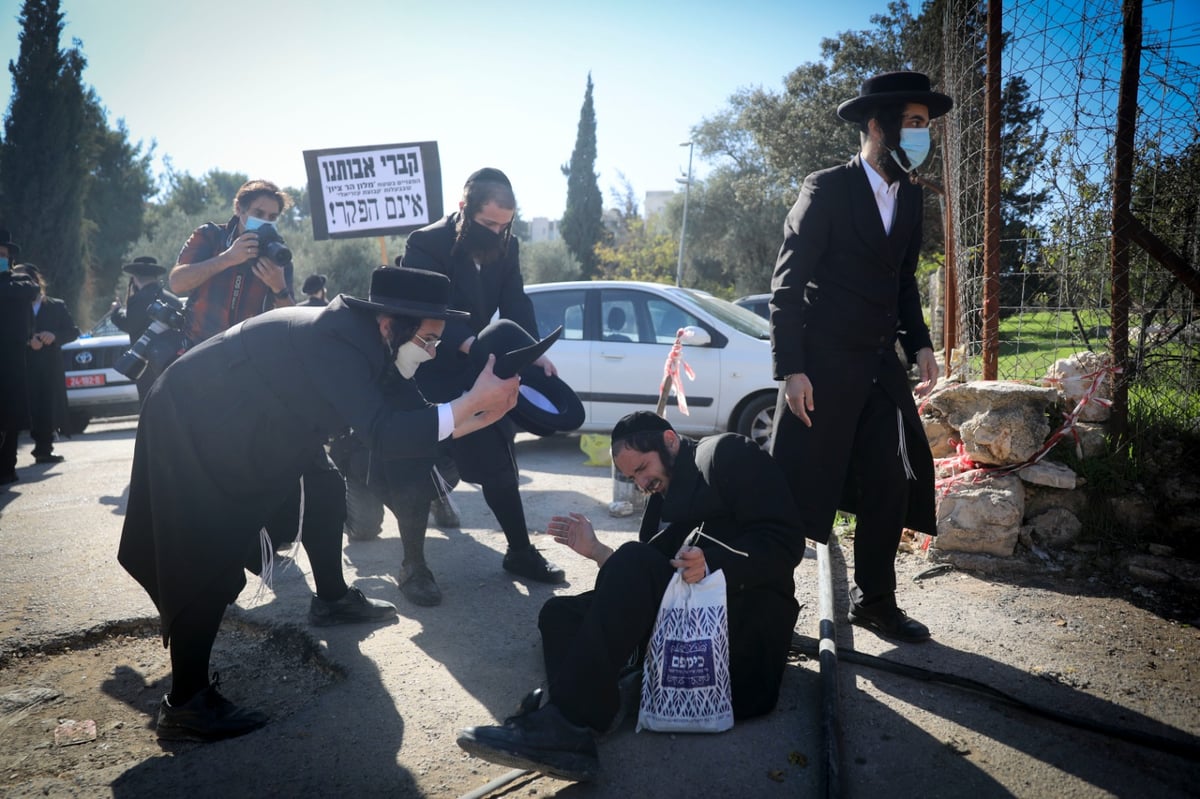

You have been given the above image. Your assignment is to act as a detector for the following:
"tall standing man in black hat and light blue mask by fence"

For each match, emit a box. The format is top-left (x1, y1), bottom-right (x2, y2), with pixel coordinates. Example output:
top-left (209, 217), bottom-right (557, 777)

top-left (770, 72), bottom-right (953, 642)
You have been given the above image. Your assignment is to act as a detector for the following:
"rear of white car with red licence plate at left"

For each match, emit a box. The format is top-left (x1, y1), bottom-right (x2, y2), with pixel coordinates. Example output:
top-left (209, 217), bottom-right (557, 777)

top-left (62, 316), bottom-right (138, 435)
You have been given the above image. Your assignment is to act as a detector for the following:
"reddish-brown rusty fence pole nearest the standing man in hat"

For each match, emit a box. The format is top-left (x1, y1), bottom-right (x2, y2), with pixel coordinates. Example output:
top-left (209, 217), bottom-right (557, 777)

top-left (983, 0), bottom-right (1004, 380)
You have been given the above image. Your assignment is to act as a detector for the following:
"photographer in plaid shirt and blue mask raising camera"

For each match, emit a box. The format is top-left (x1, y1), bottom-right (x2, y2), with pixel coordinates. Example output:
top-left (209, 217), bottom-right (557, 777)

top-left (168, 180), bottom-right (295, 347)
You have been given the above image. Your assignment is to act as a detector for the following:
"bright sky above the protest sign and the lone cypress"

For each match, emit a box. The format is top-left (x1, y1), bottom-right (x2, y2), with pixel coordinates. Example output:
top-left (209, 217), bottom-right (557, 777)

top-left (0, 0), bottom-right (886, 218)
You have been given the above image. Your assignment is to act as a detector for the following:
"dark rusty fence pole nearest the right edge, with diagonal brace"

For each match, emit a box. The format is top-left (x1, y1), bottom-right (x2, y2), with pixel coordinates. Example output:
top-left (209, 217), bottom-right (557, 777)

top-left (1109, 0), bottom-right (1141, 440)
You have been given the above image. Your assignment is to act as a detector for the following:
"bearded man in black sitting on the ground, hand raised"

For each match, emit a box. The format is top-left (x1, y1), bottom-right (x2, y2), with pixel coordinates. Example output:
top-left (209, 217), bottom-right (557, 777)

top-left (458, 410), bottom-right (804, 781)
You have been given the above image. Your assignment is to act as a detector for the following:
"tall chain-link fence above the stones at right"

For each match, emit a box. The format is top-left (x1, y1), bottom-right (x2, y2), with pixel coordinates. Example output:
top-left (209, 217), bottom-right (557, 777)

top-left (943, 0), bottom-right (1200, 447)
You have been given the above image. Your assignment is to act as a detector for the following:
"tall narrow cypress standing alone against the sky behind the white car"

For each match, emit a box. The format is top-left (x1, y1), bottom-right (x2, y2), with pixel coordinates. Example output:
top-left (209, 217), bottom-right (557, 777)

top-left (559, 72), bottom-right (604, 280)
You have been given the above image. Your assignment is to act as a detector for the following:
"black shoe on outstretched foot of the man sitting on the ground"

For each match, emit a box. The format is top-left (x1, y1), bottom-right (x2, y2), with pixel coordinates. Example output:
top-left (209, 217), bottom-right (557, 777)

top-left (458, 704), bottom-right (600, 782)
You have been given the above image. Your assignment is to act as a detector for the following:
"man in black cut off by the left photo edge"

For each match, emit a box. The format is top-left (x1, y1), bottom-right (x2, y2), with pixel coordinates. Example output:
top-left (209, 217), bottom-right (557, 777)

top-left (0, 229), bottom-right (41, 485)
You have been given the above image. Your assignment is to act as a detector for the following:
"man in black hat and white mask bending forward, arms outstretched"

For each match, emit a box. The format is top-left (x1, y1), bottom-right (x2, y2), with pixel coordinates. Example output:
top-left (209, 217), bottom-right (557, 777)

top-left (119, 268), bottom-right (517, 740)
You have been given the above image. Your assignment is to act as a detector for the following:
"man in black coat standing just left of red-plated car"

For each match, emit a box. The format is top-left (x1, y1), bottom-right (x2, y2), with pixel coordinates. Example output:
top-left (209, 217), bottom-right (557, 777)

top-left (17, 264), bottom-right (79, 463)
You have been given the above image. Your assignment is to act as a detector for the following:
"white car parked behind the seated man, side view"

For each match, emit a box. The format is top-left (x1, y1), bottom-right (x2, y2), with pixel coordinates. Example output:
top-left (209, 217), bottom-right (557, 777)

top-left (526, 281), bottom-right (779, 444)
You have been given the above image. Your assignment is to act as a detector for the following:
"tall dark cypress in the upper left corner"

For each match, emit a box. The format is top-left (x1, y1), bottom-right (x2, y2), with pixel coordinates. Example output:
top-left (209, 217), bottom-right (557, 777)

top-left (0, 0), bottom-right (90, 305)
